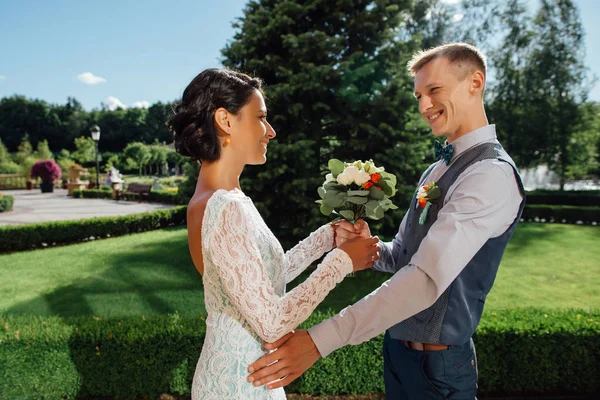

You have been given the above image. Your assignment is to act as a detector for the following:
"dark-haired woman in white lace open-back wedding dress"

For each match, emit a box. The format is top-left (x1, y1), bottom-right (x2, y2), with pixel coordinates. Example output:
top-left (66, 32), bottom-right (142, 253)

top-left (168, 69), bottom-right (379, 400)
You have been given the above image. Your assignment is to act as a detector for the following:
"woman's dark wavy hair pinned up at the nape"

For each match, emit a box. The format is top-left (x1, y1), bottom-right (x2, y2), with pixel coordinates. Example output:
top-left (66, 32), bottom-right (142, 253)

top-left (166, 68), bottom-right (262, 162)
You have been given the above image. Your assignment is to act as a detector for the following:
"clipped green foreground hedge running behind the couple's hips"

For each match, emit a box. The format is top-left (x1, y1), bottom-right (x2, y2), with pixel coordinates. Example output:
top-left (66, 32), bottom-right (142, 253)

top-left (0, 310), bottom-right (600, 399)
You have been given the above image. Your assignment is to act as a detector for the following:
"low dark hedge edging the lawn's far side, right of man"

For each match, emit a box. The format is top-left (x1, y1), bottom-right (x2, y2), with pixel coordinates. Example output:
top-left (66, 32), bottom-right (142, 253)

top-left (521, 204), bottom-right (600, 224)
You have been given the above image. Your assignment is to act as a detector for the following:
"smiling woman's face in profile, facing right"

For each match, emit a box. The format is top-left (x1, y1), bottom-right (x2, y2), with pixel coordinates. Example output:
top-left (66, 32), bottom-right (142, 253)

top-left (228, 90), bottom-right (276, 165)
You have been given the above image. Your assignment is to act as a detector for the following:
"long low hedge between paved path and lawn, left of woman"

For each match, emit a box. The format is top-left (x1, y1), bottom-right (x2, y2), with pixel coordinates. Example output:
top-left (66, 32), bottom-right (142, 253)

top-left (0, 206), bottom-right (187, 253)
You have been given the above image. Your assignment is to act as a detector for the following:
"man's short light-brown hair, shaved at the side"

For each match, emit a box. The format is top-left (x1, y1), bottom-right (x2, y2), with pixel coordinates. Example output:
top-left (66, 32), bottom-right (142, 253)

top-left (407, 43), bottom-right (487, 80)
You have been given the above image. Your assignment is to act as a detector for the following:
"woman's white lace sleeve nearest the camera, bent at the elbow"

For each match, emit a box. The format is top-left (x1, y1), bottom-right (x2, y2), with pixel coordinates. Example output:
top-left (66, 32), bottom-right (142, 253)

top-left (207, 201), bottom-right (352, 342)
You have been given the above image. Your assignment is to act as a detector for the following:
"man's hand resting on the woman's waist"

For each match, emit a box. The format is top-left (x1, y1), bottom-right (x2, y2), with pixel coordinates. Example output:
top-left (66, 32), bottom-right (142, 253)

top-left (248, 330), bottom-right (321, 389)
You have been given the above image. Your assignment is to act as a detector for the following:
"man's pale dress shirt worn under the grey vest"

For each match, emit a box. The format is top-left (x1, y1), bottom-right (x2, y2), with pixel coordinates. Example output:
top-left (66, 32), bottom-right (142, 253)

top-left (308, 125), bottom-right (522, 357)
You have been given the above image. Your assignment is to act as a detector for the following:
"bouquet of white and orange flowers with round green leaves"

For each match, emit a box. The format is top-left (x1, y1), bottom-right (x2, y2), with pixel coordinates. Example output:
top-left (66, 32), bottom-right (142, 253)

top-left (317, 159), bottom-right (398, 223)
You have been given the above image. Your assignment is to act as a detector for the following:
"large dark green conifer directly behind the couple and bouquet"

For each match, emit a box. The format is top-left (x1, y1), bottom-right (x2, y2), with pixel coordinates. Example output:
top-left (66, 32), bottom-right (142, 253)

top-left (222, 0), bottom-right (430, 244)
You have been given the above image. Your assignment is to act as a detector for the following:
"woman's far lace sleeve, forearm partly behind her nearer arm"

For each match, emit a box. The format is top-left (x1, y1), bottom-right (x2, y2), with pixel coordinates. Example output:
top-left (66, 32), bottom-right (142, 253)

top-left (285, 224), bottom-right (333, 283)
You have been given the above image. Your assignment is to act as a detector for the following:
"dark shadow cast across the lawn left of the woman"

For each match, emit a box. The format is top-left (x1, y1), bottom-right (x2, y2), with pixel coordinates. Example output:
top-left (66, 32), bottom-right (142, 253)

top-left (5, 231), bottom-right (204, 318)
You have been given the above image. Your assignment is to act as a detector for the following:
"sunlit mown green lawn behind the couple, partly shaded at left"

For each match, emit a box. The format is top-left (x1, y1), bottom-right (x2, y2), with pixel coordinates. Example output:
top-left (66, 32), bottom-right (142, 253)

top-left (0, 223), bottom-right (600, 317)
